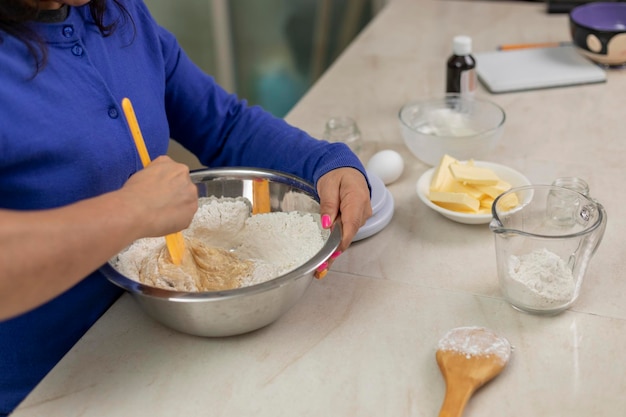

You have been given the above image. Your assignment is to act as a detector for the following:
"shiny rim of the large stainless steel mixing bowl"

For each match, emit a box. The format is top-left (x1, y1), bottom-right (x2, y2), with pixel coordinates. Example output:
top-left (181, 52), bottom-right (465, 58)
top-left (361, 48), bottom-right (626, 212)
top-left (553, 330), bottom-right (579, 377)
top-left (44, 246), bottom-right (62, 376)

top-left (99, 167), bottom-right (342, 302)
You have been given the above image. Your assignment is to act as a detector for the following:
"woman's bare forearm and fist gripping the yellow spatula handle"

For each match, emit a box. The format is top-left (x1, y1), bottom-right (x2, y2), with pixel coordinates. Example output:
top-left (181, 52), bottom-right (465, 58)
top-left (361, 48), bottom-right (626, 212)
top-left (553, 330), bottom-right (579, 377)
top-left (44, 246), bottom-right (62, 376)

top-left (0, 156), bottom-right (198, 321)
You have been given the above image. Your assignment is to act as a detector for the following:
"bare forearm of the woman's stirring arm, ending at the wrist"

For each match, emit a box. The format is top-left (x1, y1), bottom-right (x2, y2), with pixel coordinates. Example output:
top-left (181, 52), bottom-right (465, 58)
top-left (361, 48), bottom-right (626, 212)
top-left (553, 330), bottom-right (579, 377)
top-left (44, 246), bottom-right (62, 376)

top-left (0, 192), bottom-right (141, 320)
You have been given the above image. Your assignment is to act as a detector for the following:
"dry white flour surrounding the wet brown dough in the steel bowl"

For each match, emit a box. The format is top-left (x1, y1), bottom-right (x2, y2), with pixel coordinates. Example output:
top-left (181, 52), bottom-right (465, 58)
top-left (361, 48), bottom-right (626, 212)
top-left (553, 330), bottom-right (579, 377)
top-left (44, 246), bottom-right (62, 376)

top-left (111, 197), bottom-right (328, 291)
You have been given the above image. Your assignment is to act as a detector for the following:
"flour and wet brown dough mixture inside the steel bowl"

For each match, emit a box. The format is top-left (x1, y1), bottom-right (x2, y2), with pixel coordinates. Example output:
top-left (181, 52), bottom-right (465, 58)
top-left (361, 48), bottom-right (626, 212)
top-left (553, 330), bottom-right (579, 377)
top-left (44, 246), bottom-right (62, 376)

top-left (111, 197), bottom-right (328, 292)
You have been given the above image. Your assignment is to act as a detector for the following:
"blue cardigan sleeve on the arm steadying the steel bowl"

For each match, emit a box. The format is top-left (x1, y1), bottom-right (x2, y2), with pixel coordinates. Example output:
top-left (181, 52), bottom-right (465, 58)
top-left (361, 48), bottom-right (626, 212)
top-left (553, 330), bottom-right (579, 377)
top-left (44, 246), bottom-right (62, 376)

top-left (163, 41), bottom-right (365, 183)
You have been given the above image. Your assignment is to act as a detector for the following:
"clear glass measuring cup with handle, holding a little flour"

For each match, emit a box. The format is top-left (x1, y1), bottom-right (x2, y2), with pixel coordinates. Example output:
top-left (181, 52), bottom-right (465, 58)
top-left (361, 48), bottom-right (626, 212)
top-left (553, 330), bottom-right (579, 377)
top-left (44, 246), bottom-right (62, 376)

top-left (489, 185), bottom-right (607, 314)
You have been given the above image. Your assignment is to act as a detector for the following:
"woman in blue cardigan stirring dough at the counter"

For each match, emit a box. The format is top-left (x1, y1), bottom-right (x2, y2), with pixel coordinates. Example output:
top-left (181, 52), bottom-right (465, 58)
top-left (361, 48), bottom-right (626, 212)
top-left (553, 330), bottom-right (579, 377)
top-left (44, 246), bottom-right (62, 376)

top-left (0, 0), bottom-right (371, 416)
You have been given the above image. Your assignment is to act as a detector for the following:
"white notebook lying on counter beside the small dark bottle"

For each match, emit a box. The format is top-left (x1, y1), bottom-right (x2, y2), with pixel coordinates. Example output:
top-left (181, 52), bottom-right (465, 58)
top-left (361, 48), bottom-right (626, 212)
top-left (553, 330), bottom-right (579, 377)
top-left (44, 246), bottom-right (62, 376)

top-left (473, 45), bottom-right (606, 93)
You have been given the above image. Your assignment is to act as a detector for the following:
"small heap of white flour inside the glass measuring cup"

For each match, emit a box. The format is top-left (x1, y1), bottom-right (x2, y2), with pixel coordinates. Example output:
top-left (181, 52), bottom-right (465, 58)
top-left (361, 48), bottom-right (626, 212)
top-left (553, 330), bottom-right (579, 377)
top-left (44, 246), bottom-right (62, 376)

top-left (507, 248), bottom-right (576, 309)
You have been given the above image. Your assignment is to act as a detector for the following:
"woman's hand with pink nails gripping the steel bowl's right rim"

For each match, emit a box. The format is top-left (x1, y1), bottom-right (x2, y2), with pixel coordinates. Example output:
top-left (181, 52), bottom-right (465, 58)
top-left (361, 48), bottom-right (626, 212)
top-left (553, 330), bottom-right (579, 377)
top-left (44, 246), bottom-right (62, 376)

top-left (316, 168), bottom-right (372, 278)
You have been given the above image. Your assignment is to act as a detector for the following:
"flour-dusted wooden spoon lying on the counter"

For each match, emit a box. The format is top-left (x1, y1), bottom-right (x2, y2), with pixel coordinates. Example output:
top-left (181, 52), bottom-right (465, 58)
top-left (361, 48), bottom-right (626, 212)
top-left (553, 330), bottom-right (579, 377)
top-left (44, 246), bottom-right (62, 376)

top-left (436, 327), bottom-right (511, 417)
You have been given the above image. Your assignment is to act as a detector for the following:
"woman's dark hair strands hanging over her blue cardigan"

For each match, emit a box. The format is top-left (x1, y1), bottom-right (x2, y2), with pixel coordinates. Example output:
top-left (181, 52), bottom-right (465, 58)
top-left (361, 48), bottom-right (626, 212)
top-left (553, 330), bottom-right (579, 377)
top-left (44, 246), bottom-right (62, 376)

top-left (0, 0), bottom-right (132, 75)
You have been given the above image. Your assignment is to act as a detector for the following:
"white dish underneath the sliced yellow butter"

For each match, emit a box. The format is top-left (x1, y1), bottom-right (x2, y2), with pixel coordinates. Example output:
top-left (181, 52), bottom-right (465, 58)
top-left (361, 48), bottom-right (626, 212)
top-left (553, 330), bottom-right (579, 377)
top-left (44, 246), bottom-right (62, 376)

top-left (417, 161), bottom-right (530, 224)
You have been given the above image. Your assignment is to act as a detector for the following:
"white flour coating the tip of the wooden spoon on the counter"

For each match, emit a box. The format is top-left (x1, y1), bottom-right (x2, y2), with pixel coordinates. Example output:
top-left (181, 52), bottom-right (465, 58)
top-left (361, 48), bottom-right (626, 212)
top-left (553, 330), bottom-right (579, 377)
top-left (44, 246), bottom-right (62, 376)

top-left (438, 326), bottom-right (511, 363)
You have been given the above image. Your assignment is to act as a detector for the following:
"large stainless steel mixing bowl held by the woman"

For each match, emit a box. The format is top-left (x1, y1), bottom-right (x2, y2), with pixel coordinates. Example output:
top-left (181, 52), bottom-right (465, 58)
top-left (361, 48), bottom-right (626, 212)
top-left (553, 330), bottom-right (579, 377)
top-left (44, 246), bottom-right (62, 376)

top-left (101, 168), bottom-right (341, 337)
